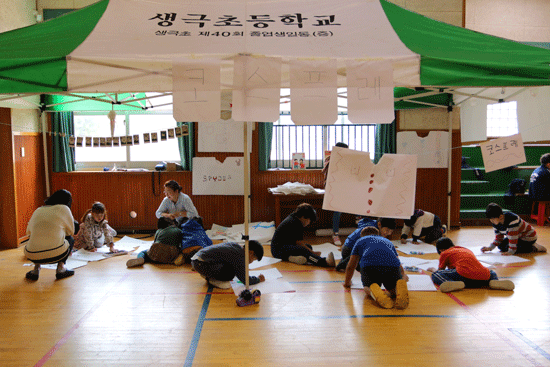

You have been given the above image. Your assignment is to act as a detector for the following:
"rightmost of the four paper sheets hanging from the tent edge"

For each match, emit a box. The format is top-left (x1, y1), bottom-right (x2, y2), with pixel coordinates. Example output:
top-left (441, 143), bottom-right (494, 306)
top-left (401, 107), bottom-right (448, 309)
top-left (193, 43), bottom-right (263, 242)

top-left (346, 61), bottom-right (394, 124)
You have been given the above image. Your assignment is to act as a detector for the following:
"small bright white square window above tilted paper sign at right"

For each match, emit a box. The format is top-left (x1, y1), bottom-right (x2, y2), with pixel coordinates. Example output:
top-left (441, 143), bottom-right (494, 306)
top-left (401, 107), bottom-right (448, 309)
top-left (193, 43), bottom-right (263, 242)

top-left (487, 102), bottom-right (518, 137)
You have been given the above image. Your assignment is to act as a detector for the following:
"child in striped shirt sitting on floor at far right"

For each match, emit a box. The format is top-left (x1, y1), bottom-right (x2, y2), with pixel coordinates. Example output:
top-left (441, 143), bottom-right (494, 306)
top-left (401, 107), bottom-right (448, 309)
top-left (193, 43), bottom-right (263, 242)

top-left (481, 203), bottom-right (546, 255)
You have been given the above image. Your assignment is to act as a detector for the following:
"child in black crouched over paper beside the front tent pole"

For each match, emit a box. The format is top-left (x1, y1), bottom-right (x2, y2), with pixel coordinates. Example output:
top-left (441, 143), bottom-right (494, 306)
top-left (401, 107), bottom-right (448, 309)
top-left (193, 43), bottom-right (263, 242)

top-left (191, 240), bottom-right (265, 289)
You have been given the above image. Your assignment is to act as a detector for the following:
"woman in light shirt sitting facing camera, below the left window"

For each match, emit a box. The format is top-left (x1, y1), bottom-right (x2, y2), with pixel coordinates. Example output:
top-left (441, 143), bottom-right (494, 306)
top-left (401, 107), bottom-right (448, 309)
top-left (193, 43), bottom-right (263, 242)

top-left (156, 180), bottom-right (199, 226)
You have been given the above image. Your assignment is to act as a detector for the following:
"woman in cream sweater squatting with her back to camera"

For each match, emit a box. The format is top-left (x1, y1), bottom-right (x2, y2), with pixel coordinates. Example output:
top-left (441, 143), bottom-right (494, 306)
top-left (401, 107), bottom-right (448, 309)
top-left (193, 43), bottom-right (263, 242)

top-left (25, 190), bottom-right (75, 281)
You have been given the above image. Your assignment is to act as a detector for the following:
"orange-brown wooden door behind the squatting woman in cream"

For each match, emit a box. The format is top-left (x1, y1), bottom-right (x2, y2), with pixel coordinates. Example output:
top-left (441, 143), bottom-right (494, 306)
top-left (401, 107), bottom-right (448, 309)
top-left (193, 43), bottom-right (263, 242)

top-left (13, 133), bottom-right (46, 241)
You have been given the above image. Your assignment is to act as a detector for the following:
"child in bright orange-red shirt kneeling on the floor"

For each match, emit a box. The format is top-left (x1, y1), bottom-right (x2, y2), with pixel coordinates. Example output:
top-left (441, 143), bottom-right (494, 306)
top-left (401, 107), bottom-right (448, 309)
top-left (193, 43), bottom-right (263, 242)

top-left (428, 237), bottom-right (514, 293)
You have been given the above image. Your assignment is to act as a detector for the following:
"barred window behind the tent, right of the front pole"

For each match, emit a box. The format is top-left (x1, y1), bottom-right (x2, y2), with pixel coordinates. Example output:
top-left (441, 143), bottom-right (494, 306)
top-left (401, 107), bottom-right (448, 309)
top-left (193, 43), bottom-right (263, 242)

top-left (270, 114), bottom-right (375, 168)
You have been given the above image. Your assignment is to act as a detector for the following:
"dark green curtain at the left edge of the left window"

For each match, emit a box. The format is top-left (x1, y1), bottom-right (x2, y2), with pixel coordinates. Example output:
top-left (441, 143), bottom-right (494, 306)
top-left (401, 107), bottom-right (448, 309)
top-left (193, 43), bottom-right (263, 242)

top-left (52, 112), bottom-right (75, 172)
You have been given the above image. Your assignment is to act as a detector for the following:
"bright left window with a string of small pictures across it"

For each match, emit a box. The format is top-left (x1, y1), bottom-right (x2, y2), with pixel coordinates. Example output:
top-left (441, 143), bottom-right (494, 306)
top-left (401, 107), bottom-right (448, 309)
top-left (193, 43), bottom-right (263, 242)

top-left (74, 112), bottom-right (181, 169)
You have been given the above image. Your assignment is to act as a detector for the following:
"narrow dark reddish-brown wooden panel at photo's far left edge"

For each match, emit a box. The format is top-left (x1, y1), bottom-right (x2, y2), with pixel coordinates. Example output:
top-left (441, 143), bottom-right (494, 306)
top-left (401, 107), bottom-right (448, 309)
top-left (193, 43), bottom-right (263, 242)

top-left (0, 108), bottom-right (18, 248)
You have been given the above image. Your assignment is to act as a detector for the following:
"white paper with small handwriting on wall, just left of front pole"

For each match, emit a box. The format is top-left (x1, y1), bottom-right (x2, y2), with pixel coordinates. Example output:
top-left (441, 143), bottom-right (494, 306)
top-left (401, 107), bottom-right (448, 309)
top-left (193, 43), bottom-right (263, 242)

top-left (193, 157), bottom-right (244, 195)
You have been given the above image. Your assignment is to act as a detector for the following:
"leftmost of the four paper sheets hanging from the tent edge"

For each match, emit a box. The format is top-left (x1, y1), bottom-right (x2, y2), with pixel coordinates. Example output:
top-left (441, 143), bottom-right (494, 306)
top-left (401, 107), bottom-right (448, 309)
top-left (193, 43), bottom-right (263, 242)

top-left (172, 60), bottom-right (221, 122)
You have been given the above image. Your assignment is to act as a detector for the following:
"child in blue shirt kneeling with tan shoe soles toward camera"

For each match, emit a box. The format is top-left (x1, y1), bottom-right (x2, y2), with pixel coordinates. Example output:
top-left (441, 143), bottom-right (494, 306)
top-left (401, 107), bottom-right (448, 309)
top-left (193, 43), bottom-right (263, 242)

top-left (344, 227), bottom-right (409, 309)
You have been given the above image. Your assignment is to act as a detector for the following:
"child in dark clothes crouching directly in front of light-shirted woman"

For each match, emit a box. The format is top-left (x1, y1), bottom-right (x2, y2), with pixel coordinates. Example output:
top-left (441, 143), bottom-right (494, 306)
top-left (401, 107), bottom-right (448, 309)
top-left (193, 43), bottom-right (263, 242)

top-left (126, 217), bottom-right (183, 268)
